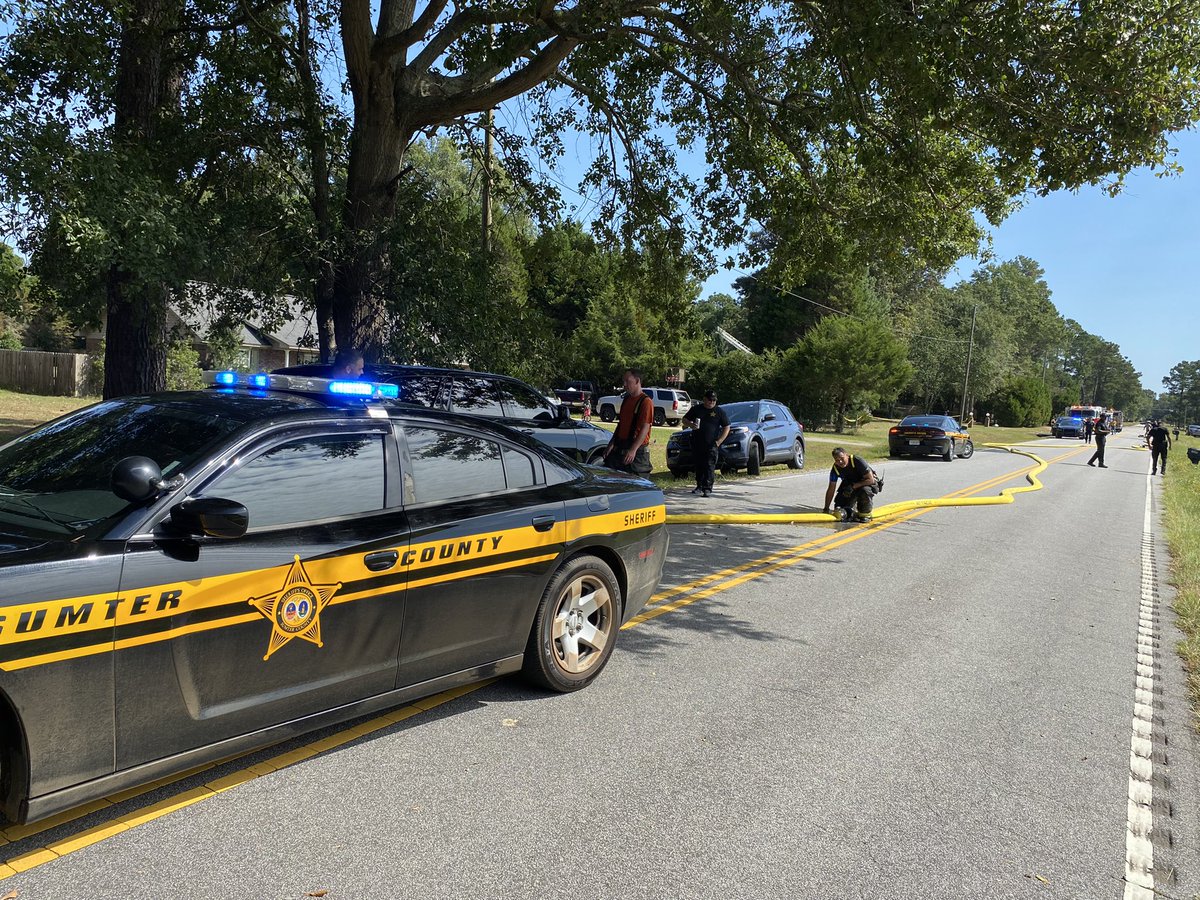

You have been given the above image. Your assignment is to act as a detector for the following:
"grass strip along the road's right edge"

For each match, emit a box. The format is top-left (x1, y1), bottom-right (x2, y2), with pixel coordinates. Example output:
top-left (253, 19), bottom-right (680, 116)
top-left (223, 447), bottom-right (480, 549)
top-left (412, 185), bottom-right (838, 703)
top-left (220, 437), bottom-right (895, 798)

top-left (1163, 434), bottom-right (1200, 731)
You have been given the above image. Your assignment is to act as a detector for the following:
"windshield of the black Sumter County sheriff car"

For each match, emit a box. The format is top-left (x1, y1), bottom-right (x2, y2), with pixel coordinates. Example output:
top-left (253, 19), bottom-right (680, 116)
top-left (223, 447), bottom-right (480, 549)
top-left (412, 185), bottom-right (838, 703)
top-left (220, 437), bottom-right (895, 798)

top-left (0, 398), bottom-right (245, 535)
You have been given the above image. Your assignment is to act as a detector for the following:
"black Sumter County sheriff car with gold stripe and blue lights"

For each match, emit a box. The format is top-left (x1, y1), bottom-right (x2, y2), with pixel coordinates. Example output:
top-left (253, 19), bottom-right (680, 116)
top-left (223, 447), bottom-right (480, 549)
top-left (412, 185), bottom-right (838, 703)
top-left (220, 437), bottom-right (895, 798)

top-left (0, 373), bottom-right (667, 821)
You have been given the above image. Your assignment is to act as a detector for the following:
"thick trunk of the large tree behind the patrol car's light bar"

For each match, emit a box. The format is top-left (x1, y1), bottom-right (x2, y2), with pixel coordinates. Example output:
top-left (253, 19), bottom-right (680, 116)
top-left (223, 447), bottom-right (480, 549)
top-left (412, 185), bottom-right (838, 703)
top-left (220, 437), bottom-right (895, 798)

top-left (334, 65), bottom-right (413, 362)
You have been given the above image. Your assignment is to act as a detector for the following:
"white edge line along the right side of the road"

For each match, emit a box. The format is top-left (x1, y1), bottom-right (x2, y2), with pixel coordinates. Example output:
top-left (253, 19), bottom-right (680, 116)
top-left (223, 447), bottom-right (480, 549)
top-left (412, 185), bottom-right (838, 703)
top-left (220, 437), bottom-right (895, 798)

top-left (1124, 472), bottom-right (1158, 900)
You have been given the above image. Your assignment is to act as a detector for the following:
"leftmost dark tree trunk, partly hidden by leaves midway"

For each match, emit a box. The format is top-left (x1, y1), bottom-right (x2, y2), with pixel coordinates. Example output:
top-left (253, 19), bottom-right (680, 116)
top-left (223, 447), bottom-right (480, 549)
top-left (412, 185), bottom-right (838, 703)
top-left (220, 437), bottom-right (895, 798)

top-left (104, 0), bottom-right (182, 398)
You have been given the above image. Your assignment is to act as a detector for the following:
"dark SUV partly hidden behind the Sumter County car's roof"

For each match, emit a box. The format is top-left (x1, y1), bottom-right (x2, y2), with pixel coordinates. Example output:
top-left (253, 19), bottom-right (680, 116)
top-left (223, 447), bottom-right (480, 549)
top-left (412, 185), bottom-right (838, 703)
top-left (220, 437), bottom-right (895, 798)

top-left (275, 362), bottom-right (612, 464)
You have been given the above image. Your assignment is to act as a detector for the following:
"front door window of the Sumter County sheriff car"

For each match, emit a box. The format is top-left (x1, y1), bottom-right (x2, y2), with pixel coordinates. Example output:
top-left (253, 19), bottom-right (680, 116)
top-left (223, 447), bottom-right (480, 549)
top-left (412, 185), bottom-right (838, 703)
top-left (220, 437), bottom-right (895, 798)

top-left (204, 434), bottom-right (385, 528)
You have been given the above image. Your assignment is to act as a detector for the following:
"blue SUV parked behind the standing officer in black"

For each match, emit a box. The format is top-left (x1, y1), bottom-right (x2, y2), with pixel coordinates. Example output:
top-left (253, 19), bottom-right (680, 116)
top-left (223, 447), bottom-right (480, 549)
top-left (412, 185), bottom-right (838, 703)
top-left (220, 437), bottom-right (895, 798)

top-left (667, 400), bottom-right (804, 478)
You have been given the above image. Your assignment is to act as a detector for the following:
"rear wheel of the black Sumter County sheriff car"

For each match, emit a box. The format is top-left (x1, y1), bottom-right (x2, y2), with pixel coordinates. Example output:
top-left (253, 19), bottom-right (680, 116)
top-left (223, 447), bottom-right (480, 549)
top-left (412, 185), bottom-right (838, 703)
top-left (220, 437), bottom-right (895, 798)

top-left (521, 556), bottom-right (623, 694)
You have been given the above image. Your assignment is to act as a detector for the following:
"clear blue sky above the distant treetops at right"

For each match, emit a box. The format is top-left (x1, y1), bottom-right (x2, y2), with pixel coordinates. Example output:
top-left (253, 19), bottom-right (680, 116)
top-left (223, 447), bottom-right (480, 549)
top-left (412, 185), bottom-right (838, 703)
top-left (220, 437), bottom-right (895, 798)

top-left (703, 132), bottom-right (1200, 392)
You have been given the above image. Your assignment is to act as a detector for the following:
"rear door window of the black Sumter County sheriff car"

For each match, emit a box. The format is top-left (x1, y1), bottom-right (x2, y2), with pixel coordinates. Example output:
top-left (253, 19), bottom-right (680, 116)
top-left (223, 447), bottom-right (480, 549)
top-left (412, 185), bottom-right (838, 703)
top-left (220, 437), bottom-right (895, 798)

top-left (404, 427), bottom-right (508, 503)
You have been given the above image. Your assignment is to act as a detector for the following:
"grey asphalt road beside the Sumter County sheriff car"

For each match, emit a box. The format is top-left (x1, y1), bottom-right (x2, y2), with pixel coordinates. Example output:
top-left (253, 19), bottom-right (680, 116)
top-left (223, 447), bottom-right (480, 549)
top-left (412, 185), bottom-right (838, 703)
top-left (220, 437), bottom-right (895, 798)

top-left (0, 433), bottom-right (1200, 900)
